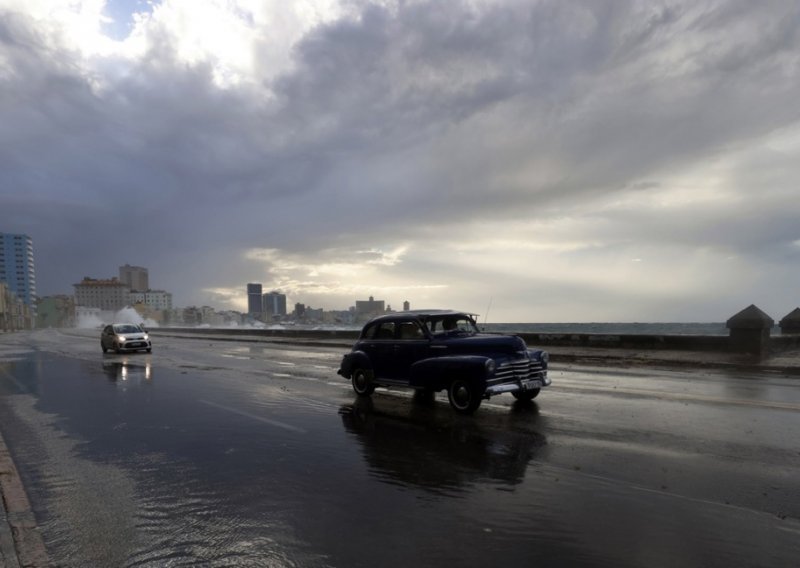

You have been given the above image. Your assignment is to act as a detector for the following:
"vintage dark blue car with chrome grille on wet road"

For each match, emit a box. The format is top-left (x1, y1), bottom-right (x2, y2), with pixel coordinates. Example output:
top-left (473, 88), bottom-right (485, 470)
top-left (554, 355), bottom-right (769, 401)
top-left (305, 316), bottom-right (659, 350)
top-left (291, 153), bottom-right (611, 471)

top-left (339, 310), bottom-right (550, 414)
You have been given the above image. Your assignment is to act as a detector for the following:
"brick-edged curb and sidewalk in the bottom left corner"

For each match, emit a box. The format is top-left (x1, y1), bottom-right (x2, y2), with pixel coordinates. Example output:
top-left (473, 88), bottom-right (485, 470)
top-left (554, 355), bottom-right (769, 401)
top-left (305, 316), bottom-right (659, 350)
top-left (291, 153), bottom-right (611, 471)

top-left (0, 434), bottom-right (52, 568)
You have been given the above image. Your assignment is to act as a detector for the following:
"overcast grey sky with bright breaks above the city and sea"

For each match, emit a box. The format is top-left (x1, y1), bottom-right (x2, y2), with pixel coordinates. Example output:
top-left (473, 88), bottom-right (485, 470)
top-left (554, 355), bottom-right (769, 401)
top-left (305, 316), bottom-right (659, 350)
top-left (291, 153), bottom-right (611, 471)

top-left (0, 0), bottom-right (800, 322)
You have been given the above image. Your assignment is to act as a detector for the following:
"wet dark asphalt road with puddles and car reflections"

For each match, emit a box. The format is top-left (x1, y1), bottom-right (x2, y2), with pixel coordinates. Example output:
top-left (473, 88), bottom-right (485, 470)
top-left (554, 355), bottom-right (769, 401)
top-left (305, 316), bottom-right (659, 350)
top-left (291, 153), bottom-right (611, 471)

top-left (0, 330), bottom-right (800, 567)
